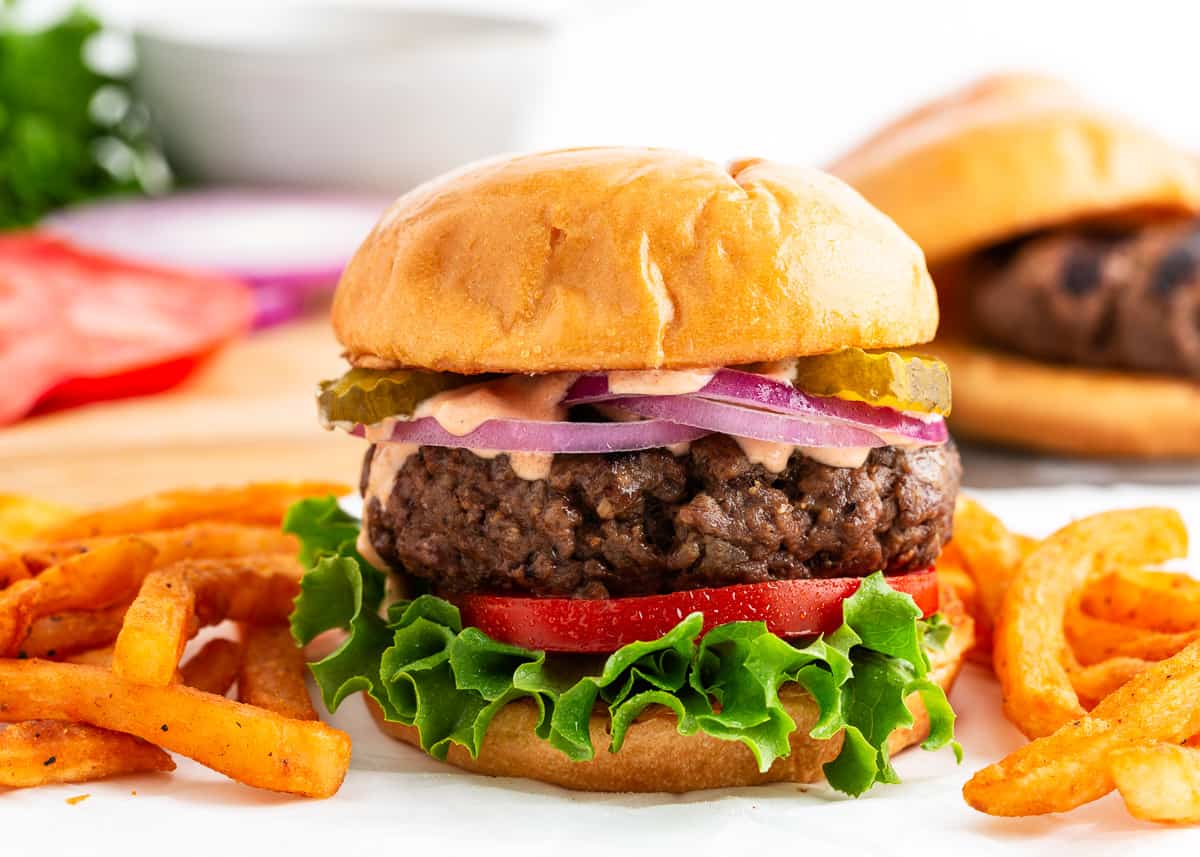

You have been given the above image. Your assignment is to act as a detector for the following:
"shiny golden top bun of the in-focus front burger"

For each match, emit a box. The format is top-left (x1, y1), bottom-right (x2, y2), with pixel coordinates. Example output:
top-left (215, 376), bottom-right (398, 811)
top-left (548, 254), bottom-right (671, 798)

top-left (334, 149), bottom-right (937, 373)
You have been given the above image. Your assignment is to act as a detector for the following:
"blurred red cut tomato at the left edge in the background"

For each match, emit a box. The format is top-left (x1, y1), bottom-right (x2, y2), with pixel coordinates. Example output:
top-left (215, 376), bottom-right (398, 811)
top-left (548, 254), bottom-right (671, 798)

top-left (0, 232), bottom-right (253, 425)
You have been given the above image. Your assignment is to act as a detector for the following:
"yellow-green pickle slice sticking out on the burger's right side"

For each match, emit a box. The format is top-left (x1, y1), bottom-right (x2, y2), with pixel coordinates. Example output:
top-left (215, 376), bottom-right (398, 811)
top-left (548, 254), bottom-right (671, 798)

top-left (792, 348), bottom-right (950, 416)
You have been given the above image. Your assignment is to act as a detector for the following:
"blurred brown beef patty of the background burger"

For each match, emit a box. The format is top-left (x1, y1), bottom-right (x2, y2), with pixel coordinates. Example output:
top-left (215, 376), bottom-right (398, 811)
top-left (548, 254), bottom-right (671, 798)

top-left (970, 222), bottom-right (1200, 378)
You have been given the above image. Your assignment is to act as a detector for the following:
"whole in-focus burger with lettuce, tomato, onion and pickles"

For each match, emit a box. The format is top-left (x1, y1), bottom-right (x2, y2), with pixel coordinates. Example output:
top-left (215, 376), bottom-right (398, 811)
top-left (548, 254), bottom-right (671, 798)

top-left (287, 149), bottom-right (972, 795)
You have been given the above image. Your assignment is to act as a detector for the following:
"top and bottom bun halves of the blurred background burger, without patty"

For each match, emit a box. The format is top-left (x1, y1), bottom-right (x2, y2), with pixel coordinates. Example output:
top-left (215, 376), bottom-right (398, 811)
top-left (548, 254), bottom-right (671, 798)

top-left (830, 74), bottom-right (1200, 457)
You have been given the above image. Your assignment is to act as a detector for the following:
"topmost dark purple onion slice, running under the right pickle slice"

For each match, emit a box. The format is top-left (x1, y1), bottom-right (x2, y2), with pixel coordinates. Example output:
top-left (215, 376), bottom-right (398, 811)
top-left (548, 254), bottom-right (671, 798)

top-left (564, 368), bottom-right (948, 447)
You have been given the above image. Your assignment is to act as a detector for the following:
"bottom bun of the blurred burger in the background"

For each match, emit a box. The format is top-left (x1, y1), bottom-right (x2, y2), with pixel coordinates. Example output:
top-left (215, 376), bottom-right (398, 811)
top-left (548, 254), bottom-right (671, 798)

top-left (929, 341), bottom-right (1200, 459)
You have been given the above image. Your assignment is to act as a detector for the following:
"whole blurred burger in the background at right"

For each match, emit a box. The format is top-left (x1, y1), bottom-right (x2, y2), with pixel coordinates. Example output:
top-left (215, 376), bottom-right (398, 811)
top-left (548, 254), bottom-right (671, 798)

top-left (832, 76), bottom-right (1200, 457)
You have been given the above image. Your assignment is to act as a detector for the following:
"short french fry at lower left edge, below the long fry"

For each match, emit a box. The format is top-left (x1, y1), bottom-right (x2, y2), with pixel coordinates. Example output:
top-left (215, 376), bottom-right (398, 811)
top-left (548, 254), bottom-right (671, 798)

top-left (0, 720), bottom-right (175, 789)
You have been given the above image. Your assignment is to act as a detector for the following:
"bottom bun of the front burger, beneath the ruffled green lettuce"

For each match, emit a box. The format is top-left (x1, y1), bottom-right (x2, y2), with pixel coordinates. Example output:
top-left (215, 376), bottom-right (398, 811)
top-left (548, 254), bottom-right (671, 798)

top-left (367, 588), bottom-right (974, 792)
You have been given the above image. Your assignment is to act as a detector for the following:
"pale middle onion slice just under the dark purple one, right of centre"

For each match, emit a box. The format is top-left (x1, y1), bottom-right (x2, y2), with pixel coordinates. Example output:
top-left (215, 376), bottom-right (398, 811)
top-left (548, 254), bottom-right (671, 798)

top-left (608, 396), bottom-right (886, 447)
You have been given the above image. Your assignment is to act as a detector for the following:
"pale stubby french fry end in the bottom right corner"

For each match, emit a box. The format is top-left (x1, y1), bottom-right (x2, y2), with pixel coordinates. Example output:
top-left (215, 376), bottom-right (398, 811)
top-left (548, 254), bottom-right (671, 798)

top-left (1109, 744), bottom-right (1200, 823)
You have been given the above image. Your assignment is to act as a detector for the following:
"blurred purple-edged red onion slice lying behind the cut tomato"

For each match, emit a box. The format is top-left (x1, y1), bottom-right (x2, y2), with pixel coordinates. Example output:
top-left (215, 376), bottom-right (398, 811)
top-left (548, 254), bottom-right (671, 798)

top-left (42, 188), bottom-right (391, 328)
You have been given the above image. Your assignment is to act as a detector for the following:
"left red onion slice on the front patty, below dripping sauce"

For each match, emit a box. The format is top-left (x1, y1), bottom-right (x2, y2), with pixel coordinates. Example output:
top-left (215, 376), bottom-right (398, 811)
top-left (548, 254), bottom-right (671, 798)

top-left (352, 416), bottom-right (708, 453)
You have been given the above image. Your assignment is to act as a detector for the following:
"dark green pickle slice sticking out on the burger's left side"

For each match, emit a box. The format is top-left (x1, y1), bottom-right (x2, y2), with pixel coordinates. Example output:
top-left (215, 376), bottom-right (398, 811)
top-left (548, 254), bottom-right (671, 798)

top-left (317, 368), bottom-right (488, 425)
